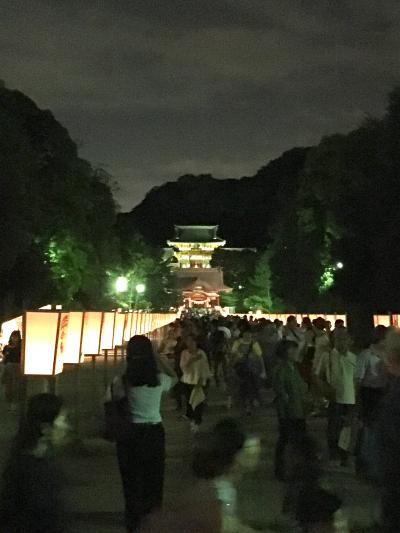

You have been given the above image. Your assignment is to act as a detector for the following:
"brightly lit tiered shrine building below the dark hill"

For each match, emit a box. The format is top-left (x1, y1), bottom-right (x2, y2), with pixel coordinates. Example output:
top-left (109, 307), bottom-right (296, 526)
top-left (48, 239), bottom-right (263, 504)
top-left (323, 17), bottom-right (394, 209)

top-left (168, 226), bottom-right (231, 307)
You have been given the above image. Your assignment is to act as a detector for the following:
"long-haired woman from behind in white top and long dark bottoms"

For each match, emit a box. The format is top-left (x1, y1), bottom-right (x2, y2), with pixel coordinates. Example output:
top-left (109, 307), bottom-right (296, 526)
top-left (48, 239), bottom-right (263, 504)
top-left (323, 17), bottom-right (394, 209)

top-left (112, 335), bottom-right (176, 533)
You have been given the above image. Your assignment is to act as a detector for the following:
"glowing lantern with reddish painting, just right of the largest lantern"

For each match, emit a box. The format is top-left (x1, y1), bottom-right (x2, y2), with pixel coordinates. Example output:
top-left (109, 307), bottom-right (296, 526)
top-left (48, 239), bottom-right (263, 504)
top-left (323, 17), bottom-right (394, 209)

top-left (58, 311), bottom-right (83, 364)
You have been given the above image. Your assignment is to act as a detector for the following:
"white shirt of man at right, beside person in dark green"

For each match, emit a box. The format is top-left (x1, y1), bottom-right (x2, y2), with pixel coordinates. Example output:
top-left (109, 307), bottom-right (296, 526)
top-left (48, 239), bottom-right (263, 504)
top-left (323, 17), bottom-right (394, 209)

top-left (329, 350), bottom-right (357, 405)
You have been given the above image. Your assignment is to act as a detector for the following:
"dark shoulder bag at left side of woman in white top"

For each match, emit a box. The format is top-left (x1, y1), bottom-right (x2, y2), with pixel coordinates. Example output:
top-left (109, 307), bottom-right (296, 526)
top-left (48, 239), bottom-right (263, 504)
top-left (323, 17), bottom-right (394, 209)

top-left (104, 376), bottom-right (133, 442)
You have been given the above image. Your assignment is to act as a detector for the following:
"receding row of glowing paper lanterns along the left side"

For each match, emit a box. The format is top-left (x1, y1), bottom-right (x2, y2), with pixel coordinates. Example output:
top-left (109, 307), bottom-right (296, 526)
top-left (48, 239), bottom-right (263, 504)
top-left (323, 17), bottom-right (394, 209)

top-left (2, 310), bottom-right (176, 376)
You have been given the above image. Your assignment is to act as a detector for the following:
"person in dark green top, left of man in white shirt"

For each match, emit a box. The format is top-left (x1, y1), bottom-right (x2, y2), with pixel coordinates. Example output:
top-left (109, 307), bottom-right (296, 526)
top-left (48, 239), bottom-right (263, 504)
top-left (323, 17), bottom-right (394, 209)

top-left (274, 340), bottom-right (307, 481)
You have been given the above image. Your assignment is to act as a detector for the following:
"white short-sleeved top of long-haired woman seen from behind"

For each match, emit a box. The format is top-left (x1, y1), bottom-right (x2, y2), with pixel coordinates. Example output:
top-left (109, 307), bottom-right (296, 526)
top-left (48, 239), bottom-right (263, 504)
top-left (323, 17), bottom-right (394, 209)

top-left (128, 374), bottom-right (176, 424)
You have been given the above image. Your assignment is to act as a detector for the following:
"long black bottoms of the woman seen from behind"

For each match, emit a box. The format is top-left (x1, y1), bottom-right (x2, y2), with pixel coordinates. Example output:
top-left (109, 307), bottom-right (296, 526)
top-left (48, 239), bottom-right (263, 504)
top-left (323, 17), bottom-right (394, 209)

top-left (117, 424), bottom-right (165, 531)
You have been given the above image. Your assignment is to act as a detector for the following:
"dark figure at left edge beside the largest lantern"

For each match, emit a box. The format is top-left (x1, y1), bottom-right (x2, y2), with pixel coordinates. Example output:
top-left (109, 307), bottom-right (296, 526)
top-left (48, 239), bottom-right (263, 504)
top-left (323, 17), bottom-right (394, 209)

top-left (2, 330), bottom-right (21, 411)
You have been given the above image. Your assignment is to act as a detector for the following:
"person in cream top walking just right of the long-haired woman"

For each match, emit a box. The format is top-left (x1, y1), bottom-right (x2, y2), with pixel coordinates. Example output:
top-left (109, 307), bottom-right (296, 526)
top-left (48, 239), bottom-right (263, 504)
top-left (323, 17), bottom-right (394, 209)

top-left (180, 336), bottom-right (211, 432)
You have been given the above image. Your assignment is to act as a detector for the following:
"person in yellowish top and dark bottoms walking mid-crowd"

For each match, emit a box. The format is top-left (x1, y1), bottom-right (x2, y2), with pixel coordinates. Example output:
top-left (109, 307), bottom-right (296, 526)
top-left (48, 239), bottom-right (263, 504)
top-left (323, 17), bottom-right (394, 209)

top-left (232, 326), bottom-right (266, 415)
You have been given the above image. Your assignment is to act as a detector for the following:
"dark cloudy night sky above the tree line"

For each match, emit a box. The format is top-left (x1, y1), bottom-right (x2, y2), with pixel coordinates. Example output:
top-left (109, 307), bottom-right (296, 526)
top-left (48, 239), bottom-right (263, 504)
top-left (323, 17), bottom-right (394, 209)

top-left (0, 0), bottom-right (400, 210)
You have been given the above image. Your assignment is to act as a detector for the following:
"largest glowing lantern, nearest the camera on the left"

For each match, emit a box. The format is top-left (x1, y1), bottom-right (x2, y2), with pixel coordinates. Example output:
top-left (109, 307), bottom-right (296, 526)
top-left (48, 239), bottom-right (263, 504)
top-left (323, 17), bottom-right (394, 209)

top-left (22, 311), bottom-right (63, 376)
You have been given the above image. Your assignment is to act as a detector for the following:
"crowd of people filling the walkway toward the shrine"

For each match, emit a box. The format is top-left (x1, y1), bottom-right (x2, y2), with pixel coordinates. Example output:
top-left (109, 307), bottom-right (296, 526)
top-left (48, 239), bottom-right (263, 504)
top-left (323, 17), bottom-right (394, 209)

top-left (2, 316), bottom-right (400, 533)
